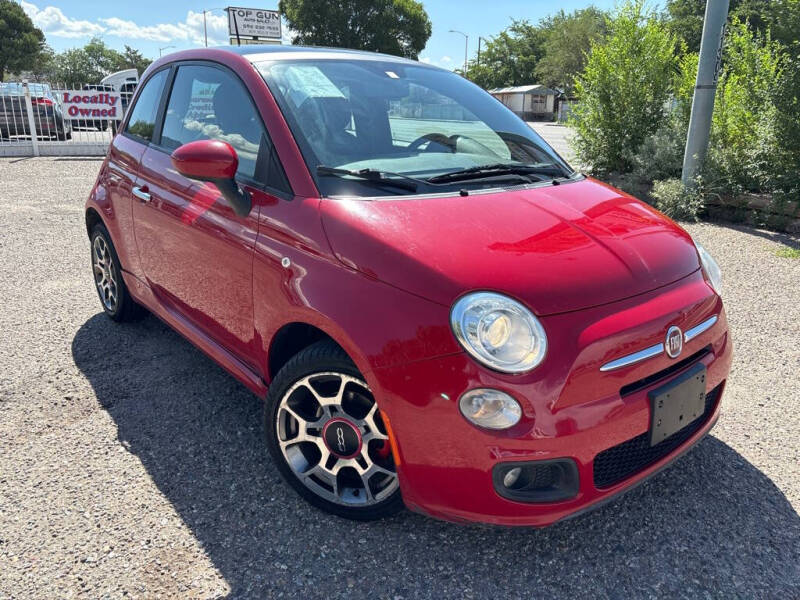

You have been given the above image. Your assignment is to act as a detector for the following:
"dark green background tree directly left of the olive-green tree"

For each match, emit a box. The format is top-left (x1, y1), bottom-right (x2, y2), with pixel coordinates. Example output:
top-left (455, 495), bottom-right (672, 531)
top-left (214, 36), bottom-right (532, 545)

top-left (466, 21), bottom-right (544, 89)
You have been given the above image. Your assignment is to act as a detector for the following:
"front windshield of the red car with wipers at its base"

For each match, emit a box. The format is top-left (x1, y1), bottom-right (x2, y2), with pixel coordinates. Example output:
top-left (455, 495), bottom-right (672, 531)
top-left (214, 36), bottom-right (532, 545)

top-left (256, 59), bottom-right (573, 196)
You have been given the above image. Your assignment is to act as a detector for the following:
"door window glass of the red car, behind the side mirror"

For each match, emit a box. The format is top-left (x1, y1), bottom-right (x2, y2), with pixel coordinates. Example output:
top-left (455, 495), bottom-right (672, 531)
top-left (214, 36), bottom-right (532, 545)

top-left (161, 65), bottom-right (269, 179)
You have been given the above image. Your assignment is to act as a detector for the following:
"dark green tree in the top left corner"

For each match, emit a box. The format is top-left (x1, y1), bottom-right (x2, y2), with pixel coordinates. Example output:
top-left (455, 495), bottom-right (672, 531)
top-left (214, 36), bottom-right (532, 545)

top-left (0, 0), bottom-right (44, 81)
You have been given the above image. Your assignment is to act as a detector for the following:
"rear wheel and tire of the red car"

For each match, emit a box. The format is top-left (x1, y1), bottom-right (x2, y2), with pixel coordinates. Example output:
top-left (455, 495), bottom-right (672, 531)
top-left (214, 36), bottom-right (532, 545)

top-left (89, 223), bottom-right (145, 322)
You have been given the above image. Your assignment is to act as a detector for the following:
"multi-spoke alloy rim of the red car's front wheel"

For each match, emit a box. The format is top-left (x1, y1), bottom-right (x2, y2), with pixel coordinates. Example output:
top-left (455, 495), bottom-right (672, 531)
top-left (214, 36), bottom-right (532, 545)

top-left (275, 371), bottom-right (398, 507)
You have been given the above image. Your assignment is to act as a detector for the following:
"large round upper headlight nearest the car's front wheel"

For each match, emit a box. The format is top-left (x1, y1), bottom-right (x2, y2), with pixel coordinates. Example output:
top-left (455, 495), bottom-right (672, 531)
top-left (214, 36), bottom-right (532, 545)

top-left (450, 292), bottom-right (547, 373)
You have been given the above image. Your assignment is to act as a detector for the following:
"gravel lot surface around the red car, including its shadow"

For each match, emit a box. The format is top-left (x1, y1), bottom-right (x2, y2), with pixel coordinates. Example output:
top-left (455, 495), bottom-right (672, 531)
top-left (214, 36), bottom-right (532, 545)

top-left (0, 159), bottom-right (800, 599)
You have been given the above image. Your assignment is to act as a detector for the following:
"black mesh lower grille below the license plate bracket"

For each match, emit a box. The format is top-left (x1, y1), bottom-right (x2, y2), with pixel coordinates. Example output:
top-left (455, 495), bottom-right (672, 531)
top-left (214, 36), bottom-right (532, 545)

top-left (594, 385), bottom-right (721, 488)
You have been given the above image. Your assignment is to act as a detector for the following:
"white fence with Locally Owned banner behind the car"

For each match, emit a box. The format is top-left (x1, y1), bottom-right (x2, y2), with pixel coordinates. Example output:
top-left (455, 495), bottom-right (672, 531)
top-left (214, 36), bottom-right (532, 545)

top-left (0, 80), bottom-right (135, 156)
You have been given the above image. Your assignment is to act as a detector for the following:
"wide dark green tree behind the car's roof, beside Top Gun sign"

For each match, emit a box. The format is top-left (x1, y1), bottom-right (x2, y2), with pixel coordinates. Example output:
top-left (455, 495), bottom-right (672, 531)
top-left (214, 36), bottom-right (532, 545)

top-left (278, 0), bottom-right (432, 58)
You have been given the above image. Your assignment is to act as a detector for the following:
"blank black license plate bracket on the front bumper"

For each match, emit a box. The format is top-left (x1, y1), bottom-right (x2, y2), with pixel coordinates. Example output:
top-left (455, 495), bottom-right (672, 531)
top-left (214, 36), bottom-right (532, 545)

top-left (647, 363), bottom-right (706, 446)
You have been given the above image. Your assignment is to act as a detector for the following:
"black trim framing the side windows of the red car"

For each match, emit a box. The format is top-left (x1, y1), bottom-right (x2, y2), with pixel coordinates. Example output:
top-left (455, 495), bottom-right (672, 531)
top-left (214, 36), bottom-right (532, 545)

top-left (139, 59), bottom-right (294, 200)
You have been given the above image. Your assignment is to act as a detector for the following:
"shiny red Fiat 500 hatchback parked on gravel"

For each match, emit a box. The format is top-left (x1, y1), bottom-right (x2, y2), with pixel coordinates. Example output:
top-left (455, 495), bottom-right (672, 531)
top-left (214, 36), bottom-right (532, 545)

top-left (86, 46), bottom-right (731, 525)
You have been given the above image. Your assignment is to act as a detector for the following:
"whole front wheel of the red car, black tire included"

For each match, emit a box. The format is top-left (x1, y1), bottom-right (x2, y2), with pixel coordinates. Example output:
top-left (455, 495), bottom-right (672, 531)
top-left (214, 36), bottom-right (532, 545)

top-left (264, 341), bottom-right (403, 521)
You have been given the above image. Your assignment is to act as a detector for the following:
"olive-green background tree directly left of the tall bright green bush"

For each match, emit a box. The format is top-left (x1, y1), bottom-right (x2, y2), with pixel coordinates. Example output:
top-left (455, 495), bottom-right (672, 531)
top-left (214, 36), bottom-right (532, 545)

top-left (536, 6), bottom-right (606, 91)
